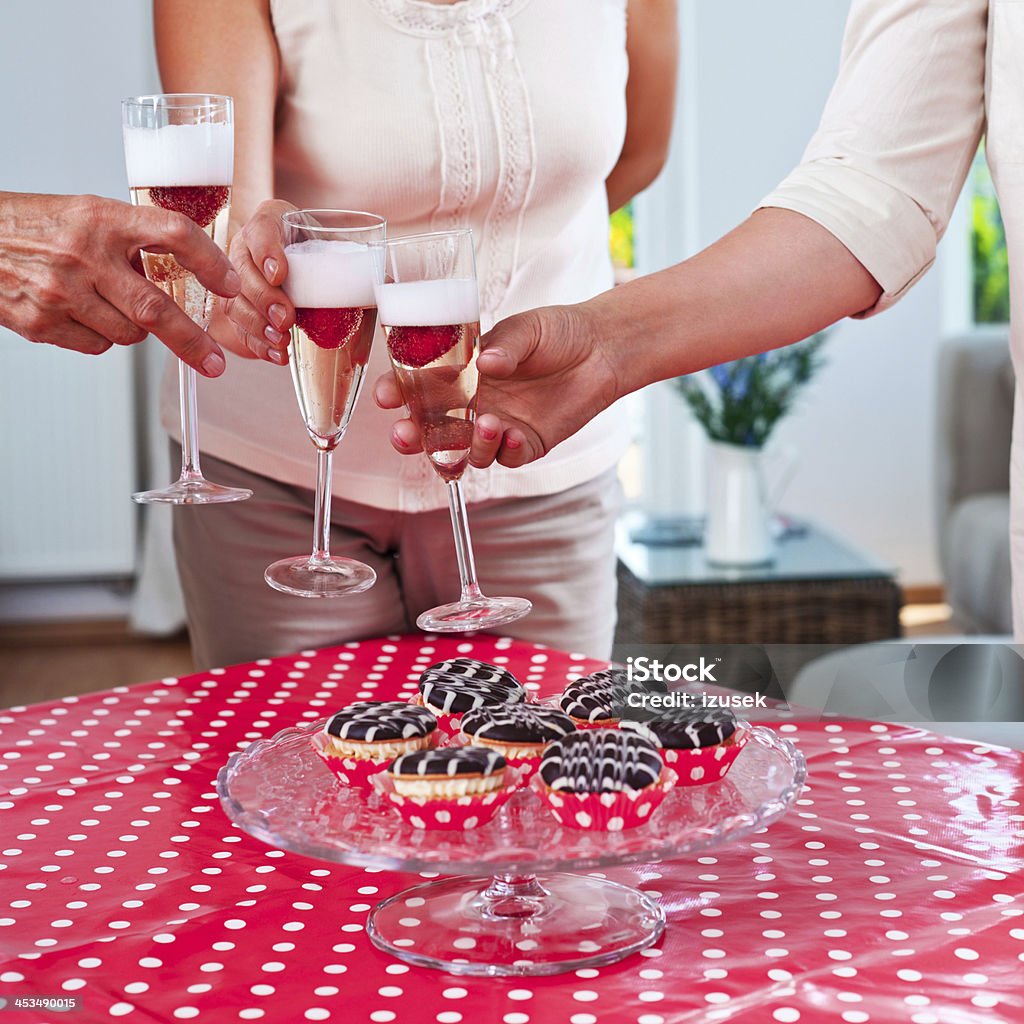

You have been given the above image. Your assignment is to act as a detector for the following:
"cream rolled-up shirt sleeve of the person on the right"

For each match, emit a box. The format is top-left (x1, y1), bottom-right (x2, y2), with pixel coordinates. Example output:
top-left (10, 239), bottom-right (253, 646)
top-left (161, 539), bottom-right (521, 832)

top-left (761, 0), bottom-right (989, 316)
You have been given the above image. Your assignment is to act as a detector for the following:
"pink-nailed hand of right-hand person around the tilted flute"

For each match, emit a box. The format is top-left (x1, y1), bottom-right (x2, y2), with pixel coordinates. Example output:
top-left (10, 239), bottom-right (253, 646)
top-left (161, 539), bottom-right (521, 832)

top-left (374, 306), bottom-right (623, 468)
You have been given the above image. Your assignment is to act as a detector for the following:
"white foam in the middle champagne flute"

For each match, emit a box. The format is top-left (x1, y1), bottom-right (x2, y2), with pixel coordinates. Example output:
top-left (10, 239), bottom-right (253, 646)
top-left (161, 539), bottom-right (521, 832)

top-left (285, 239), bottom-right (374, 309)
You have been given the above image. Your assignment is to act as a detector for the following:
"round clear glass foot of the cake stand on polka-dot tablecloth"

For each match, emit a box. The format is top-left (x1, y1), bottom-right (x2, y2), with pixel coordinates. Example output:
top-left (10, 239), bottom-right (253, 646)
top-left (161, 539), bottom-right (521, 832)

top-left (367, 873), bottom-right (665, 977)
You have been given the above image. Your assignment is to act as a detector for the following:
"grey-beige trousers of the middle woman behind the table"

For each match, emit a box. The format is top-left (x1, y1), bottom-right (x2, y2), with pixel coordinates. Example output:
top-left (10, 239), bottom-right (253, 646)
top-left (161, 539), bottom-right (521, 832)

top-left (172, 445), bottom-right (622, 670)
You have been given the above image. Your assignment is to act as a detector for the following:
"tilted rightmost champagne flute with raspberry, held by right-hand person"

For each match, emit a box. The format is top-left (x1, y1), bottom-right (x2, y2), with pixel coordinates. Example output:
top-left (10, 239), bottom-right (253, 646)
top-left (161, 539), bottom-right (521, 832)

top-left (371, 230), bottom-right (532, 633)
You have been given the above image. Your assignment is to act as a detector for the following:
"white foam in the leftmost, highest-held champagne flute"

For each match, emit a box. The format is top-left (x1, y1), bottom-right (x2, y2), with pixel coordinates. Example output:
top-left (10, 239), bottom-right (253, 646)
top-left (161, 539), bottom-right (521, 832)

top-left (124, 124), bottom-right (234, 188)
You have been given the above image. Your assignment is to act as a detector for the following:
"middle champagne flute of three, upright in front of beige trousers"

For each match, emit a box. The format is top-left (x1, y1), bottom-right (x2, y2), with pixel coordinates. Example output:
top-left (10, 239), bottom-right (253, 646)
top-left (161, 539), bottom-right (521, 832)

top-left (263, 210), bottom-right (385, 597)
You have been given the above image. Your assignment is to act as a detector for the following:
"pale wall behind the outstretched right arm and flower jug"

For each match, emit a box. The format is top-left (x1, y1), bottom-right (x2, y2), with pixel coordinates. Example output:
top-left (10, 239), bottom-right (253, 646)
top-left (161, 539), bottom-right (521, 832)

top-left (637, 0), bottom-right (940, 584)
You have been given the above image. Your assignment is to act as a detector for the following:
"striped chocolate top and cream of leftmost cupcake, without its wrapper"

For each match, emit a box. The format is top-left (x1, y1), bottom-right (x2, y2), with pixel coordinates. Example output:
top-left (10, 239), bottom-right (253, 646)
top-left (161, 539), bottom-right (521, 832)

top-left (324, 700), bottom-right (437, 761)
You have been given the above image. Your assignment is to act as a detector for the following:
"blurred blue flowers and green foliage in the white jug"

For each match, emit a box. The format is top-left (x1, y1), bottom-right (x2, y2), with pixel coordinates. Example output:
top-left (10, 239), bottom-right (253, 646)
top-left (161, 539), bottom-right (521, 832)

top-left (676, 332), bottom-right (825, 447)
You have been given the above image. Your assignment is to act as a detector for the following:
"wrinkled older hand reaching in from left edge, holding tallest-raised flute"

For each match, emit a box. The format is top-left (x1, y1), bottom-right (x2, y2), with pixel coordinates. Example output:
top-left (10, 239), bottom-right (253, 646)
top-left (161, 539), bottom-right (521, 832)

top-left (0, 194), bottom-right (240, 377)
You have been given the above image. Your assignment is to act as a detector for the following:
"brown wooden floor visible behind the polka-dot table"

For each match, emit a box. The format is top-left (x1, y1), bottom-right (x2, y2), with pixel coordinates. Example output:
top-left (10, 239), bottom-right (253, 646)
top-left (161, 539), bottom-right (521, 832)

top-left (0, 604), bottom-right (956, 708)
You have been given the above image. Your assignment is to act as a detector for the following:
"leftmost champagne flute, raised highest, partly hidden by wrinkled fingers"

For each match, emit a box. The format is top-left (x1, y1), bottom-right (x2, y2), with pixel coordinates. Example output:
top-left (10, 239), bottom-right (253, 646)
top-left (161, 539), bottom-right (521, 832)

top-left (121, 93), bottom-right (252, 505)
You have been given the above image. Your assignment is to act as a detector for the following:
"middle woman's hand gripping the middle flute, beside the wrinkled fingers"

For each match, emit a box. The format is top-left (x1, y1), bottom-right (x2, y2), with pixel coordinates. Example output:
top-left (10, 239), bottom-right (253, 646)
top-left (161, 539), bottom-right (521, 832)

top-left (224, 199), bottom-right (295, 367)
